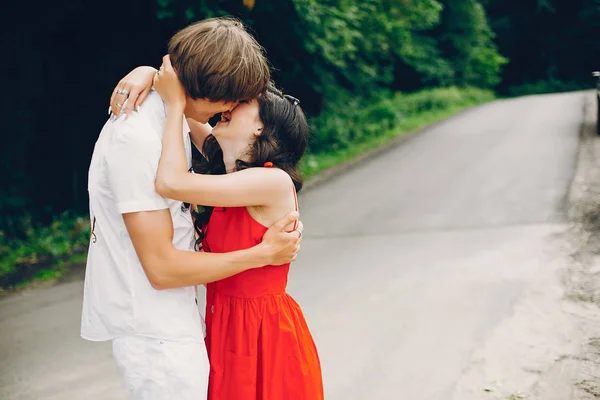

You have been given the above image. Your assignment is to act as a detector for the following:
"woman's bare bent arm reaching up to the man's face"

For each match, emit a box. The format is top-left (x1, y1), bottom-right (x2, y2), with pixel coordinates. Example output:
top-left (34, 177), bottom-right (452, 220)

top-left (154, 56), bottom-right (292, 207)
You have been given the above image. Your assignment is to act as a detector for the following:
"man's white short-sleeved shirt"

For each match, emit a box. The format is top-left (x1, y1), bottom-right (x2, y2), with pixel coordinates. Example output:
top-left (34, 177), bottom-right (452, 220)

top-left (81, 91), bottom-right (204, 341)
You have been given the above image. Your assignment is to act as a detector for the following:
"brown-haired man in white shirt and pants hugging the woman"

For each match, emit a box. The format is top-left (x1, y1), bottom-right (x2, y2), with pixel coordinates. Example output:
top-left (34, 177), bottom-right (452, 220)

top-left (81, 19), bottom-right (301, 400)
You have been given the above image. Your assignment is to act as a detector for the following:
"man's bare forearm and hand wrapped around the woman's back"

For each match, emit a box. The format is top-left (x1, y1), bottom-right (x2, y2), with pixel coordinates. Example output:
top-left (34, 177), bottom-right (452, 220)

top-left (123, 209), bottom-right (300, 289)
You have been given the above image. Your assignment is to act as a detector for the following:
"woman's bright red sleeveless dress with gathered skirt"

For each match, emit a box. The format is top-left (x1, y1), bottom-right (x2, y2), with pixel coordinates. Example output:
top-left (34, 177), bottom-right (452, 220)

top-left (204, 181), bottom-right (323, 400)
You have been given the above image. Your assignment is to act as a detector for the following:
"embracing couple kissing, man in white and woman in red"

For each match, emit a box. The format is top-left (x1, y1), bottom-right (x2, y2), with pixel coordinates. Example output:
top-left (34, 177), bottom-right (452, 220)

top-left (81, 18), bottom-right (323, 400)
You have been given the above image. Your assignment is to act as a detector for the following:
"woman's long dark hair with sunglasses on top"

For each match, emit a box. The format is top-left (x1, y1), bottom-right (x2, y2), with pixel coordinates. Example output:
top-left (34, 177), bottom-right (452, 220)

top-left (192, 82), bottom-right (309, 247)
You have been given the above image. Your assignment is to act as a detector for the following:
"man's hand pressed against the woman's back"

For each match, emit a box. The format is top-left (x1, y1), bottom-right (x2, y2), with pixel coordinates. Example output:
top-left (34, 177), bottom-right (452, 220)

top-left (261, 211), bottom-right (304, 265)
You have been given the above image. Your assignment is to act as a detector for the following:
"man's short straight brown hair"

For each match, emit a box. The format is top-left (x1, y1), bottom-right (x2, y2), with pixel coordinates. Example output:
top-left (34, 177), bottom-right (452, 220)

top-left (169, 18), bottom-right (270, 102)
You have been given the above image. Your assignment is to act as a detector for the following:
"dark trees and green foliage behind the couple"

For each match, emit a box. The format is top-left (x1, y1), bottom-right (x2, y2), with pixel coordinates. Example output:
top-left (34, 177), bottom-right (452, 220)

top-left (0, 0), bottom-right (600, 260)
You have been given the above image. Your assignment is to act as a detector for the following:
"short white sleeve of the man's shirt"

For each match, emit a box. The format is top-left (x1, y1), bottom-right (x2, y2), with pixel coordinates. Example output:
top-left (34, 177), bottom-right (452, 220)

top-left (106, 130), bottom-right (169, 214)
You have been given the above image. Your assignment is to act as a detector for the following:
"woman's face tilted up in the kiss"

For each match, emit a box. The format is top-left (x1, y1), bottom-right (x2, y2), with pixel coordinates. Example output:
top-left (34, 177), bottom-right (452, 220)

top-left (212, 99), bottom-right (263, 143)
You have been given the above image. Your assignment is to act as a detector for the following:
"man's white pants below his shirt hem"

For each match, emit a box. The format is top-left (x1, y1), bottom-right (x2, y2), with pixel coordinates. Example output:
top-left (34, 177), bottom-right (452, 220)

top-left (113, 336), bottom-right (210, 400)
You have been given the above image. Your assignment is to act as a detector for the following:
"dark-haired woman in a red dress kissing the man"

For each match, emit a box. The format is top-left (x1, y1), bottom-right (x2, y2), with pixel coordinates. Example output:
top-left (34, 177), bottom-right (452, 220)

top-left (119, 56), bottom-right (323, 400)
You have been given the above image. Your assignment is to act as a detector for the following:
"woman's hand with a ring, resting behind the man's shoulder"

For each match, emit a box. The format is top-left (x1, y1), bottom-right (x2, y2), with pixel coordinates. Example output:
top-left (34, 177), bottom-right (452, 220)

top-left (109, 67), bottom-right (156, 116)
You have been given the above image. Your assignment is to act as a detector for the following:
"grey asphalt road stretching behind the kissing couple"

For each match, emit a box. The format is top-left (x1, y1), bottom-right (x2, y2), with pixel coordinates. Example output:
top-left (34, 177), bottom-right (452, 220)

top-left (0, 93), bottom-right (584, 400)
